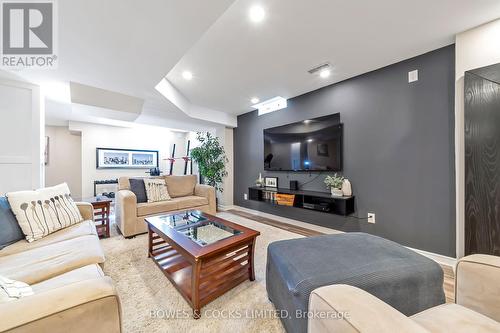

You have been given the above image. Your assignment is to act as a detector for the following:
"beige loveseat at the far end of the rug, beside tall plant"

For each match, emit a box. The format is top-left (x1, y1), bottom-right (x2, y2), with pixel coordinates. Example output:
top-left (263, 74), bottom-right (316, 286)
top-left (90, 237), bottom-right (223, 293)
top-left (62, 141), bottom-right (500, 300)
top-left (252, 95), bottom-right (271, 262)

top-left (116, 175), bottom-right (216, 237)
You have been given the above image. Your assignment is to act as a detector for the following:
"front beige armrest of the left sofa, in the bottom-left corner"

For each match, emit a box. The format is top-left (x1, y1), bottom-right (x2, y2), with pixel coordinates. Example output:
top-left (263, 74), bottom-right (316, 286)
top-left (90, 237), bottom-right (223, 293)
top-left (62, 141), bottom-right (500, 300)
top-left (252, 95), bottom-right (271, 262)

top-left (0, 277), bottom-right (119, 333)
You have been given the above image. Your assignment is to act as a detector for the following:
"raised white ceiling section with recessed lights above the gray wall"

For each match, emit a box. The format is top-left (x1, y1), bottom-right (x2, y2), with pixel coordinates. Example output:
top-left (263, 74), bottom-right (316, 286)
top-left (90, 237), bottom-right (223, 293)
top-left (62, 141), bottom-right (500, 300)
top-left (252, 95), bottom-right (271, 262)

top-left (167, 0), bottom-right (500, 114)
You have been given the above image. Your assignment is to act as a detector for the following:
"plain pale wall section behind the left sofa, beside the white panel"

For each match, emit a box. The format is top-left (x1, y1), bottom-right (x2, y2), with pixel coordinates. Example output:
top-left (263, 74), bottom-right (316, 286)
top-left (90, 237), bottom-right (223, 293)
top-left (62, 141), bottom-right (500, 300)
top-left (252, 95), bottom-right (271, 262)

top-left (45, 126), bottom-right (82, 198)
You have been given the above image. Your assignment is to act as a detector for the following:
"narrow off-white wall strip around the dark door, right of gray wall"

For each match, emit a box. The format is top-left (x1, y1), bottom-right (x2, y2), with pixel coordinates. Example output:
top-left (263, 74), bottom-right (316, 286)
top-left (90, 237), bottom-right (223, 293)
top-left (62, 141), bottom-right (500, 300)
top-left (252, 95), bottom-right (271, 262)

top-left (455, 20), bottom-right (500, 258)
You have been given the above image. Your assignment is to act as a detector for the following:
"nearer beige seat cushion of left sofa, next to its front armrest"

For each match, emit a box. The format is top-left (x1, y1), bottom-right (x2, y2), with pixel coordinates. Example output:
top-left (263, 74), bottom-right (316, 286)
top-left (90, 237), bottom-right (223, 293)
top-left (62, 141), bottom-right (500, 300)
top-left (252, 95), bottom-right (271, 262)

top-left (0, 235), bottom-right (104, 284)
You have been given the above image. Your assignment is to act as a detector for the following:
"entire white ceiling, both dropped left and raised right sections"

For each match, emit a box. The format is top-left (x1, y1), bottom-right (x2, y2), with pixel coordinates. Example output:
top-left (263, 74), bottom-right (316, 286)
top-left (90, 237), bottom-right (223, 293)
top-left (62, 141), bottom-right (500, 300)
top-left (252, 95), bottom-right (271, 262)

top-left (5, 0), bottom-right (500, 128)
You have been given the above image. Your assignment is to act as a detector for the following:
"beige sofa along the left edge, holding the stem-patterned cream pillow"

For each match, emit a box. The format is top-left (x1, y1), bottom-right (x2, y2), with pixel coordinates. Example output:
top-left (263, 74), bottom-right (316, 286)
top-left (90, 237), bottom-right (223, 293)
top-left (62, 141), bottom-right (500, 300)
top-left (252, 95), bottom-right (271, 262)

top-left (0, 203), bottom-right (121, 333)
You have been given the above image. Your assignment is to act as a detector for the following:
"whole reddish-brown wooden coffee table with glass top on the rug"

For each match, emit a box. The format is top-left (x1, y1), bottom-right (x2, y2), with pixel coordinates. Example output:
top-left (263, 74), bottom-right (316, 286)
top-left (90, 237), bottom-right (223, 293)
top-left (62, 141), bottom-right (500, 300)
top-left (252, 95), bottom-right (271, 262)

top-left (146, 211), bottom-right (260, 319)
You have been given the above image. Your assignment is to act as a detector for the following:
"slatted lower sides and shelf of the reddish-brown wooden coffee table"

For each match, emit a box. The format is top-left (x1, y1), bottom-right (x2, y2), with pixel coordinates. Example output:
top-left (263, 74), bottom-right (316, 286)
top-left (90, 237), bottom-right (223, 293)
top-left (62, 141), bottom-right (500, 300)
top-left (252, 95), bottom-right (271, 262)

top-left (150, 238), bottom-right (250, 306)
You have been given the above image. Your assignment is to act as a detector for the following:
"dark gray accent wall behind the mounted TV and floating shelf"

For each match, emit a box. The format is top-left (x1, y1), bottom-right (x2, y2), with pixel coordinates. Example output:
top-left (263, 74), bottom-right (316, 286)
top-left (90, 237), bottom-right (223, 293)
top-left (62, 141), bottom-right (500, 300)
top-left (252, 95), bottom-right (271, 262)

top-left (234, 45), bottom-right (455, 257)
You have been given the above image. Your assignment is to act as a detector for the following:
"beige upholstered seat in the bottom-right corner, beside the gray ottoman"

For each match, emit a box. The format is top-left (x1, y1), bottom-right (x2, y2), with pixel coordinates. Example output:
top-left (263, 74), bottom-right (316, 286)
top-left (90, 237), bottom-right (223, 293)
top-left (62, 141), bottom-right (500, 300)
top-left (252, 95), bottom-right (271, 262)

top-left (308, 254), bottom-right (500, 333)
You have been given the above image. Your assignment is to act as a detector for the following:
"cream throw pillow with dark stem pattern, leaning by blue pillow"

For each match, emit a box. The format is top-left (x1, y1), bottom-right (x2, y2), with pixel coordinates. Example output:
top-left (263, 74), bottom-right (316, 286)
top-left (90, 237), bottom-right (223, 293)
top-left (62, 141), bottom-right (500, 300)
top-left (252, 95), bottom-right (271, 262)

top-left (6, 183), bottom-right (83, 242)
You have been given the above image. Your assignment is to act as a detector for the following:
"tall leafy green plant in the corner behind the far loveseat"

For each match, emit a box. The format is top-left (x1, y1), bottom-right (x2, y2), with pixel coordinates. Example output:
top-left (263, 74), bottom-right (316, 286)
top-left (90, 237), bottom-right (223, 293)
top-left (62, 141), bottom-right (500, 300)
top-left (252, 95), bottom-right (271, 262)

top-left (191, 132), bottom-right (229, 192)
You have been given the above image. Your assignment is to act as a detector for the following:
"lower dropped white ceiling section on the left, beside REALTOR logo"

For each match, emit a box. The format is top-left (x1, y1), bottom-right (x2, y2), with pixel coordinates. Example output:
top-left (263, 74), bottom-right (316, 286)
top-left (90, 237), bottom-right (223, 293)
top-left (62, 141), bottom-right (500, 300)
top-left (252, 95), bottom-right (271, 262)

top-left (12, 0), bottom-right (234, 128)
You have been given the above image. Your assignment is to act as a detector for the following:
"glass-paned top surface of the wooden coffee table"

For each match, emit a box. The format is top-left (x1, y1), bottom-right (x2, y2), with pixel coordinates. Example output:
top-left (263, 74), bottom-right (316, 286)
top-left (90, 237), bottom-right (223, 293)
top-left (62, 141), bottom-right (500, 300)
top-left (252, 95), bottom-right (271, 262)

top-left (148, 211), bottom-right (242, 246)
